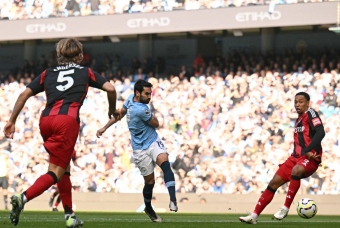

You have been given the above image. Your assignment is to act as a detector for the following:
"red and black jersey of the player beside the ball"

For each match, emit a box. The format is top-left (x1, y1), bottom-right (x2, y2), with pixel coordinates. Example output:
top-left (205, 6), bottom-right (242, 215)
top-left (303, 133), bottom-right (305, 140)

top-left (292, 108), bottom-right (323, 157)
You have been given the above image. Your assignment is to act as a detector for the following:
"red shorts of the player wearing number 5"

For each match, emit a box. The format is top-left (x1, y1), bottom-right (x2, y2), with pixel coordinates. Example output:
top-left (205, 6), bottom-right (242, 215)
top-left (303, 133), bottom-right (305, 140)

top-left (39, 115), bottom-right (79, 169)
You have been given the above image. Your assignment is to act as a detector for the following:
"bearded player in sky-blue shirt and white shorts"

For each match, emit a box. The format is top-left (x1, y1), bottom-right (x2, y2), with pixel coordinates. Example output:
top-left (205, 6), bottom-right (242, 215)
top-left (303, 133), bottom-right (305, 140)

top-left (97, 80), bottom-right (178, 222)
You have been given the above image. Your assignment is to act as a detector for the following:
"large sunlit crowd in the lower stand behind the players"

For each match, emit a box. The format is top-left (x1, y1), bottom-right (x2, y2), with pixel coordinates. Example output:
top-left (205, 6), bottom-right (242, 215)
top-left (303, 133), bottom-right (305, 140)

top-left (0, 49), bottom-right (340, 195)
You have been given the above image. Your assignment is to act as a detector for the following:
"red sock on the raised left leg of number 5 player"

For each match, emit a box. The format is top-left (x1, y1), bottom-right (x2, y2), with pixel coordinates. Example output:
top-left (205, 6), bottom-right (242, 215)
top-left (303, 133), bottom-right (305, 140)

top-left (24, 172), bottom-right (57, 202)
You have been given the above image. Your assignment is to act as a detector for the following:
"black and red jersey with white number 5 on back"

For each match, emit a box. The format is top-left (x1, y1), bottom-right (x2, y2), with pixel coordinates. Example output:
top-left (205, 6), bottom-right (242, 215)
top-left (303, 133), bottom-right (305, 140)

top-left (27, 63), bottom-right (107, 122)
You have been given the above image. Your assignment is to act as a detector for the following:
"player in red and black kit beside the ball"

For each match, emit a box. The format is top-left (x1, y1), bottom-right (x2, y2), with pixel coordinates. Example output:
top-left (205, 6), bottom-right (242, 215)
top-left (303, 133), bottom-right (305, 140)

top-left (240, 92), bottom-right (325, 224)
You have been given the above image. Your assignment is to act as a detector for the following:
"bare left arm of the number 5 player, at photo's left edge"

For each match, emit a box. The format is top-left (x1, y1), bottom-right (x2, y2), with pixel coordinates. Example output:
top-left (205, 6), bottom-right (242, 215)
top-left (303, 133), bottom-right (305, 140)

top-left (4, 88), bottom-right (34, 139)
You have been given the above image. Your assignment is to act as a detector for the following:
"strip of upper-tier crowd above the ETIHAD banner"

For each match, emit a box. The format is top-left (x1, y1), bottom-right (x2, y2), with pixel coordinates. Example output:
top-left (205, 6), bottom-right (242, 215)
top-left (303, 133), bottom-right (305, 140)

top-left (0, 0), bottom-right (324, 20)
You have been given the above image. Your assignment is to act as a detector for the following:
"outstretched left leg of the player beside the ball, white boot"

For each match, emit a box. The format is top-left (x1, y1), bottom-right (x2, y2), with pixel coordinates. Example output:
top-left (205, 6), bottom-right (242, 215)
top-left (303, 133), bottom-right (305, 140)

top-left (239, 159), bottom-right (294, 224)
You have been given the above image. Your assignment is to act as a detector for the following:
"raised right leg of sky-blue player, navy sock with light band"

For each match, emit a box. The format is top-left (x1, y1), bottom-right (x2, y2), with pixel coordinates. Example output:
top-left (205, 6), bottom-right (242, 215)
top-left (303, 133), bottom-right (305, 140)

top-left (156, 153), bottom-right (178, 212)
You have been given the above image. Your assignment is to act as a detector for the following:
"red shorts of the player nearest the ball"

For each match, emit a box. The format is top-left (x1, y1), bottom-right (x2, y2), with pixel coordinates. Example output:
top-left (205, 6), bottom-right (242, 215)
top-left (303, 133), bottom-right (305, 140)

top-left (276, 156), bottom-right (320, 182)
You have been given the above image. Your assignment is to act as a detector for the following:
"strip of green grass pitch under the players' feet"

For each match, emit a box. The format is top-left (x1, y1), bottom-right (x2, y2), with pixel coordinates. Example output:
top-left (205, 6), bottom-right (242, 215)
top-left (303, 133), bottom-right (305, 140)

top-left (0, 211), bottom-right (340, 228)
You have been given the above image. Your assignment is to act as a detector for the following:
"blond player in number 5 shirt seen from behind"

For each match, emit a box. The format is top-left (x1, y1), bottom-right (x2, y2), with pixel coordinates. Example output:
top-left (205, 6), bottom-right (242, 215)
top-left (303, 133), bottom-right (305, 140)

top-left (4, 38), bottom-right (119, 227)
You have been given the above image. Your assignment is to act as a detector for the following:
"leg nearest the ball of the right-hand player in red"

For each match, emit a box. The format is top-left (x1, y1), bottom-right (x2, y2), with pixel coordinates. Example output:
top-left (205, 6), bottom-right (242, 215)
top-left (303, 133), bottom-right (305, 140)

top-left (274, 156), bottom-right (319, 220)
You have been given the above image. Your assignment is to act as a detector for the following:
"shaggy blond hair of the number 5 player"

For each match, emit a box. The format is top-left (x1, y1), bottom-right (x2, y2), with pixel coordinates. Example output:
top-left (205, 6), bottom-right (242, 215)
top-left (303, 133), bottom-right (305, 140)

top-left (56, 38), bottom-right (84, 65)
